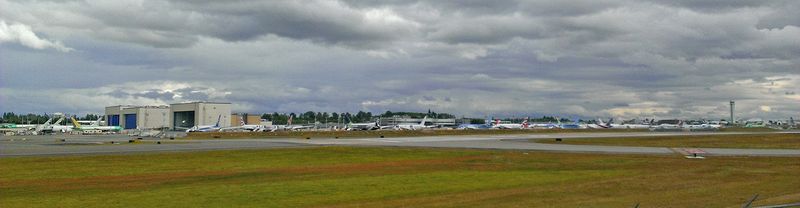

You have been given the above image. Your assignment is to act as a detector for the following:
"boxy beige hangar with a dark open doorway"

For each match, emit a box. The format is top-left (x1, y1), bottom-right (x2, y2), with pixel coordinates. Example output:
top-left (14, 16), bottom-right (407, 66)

top-left (168, 102), bottom-right (231, 130)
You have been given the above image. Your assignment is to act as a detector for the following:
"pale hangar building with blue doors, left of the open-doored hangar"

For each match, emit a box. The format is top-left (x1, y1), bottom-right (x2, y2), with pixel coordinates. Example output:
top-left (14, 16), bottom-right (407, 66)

top-left (105, 105), bottom-right (169, 129)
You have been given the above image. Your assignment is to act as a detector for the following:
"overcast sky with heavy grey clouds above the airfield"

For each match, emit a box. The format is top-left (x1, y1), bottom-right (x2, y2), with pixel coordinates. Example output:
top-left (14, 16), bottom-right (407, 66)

top-left (0, 0), bottom-right (800, 119)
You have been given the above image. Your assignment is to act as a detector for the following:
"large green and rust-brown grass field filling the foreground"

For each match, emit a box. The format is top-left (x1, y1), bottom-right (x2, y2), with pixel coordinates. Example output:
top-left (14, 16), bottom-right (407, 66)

top-left (0, 147), bottom-right (800, 208)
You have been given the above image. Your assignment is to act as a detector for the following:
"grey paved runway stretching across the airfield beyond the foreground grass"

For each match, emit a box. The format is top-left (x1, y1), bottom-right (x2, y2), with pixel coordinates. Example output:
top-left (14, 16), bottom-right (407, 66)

top-left (0, 132), bottom-right (800, 157)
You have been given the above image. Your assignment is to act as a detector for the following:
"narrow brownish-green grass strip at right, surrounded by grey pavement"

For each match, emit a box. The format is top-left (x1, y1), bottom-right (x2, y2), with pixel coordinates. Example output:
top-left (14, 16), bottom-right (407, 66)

top-left (535, 134), bottom-right (800, 149)
